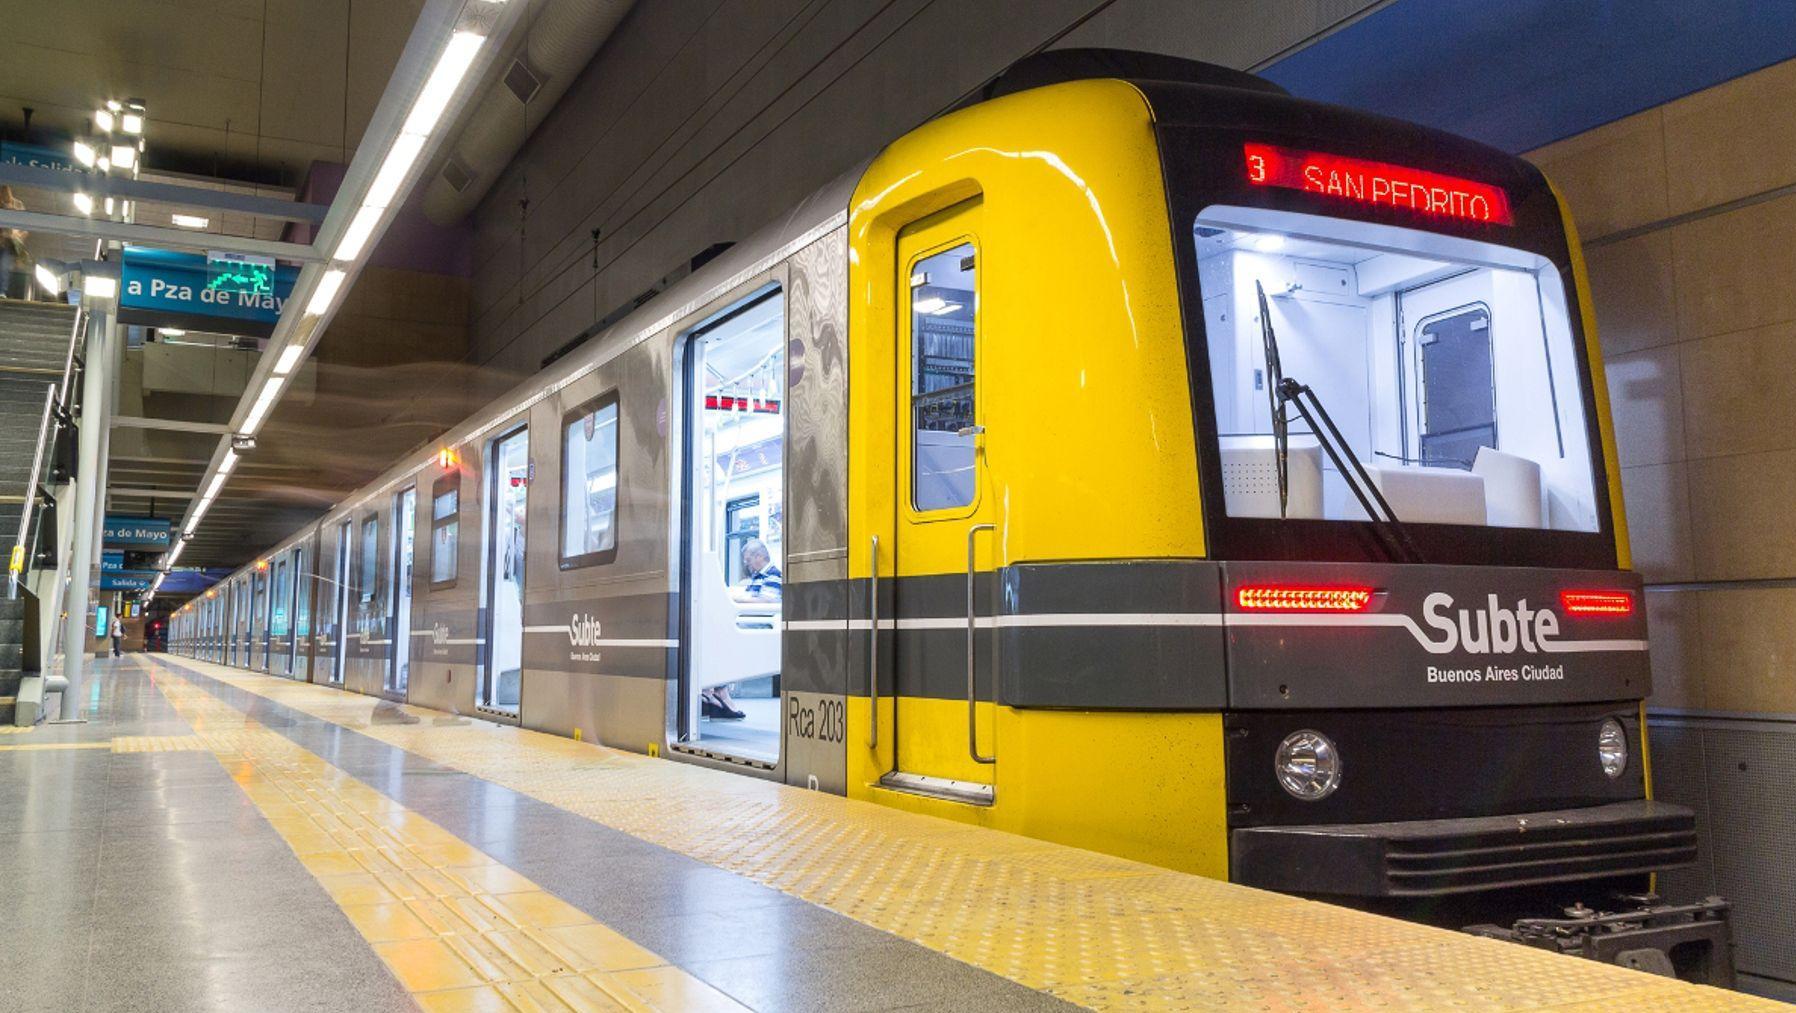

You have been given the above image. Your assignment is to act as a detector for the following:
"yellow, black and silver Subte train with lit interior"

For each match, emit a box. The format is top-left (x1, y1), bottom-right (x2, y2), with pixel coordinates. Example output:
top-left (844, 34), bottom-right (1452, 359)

top-left (172, 50), bottom-right (1715, 952)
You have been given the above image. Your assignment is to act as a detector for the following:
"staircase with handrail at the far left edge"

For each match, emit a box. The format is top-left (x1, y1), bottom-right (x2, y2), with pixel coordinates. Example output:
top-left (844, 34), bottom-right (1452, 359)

top-left (0, 298), bottom-right (75, 724)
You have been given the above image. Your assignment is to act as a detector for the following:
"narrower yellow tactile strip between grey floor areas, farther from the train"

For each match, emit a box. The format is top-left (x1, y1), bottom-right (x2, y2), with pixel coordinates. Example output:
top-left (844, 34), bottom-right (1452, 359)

top-left (141, 672), bottom-right (744, 1013)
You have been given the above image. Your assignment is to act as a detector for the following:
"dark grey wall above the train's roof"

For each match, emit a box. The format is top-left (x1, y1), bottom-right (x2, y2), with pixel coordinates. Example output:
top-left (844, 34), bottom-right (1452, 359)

top-left (471, 0), bottom-right (1372, 374)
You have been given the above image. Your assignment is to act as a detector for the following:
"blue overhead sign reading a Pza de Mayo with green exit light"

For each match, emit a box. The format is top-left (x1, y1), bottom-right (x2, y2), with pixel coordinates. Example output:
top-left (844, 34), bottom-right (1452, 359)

top-left (119, 246), bottom-right (300, 338)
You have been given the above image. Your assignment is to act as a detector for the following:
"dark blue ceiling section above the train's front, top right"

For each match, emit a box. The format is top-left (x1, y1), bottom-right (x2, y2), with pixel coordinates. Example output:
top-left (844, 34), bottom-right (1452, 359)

top-left (1261, 0), bottom-right (1796, 151)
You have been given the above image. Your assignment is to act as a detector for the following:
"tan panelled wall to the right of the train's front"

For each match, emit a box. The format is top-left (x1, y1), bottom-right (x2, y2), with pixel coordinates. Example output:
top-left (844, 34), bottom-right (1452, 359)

top-left (1530, 61), bottom-right (1796, 981)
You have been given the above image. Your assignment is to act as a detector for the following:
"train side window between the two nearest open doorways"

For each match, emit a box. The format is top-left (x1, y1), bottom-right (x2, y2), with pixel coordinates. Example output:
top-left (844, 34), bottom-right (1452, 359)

top-left (560, 392), bottom-right (618, 569)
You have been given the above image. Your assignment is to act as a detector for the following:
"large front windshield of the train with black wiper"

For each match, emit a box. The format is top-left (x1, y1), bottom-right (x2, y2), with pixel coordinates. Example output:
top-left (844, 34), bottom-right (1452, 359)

top-left (1194, 207), bottom-right (1598, 532)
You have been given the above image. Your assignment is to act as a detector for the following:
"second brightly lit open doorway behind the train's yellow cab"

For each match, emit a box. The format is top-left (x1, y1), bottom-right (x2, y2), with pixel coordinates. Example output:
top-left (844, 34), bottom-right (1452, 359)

top-left (478, 427), bottom-right (530, 715)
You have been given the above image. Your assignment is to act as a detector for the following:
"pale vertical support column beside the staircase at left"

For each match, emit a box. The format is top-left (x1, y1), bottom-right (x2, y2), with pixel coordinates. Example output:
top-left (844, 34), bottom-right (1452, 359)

top-left (59, 302), bottom-right (117, 720)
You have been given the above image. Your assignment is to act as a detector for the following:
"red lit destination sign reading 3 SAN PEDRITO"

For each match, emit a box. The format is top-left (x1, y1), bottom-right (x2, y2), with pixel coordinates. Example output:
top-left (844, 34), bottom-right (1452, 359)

top-left (1243, 144), bottom-right (1516, 225)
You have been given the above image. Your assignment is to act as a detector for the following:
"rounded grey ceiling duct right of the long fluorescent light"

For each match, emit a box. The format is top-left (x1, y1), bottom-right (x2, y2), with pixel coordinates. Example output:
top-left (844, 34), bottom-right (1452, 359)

top-left (424, 0), bottom-right (632, 225)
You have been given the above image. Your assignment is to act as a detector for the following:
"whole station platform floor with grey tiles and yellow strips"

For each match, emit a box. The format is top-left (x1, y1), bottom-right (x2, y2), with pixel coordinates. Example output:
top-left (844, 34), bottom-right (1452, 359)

top-left (0, 656), bottom-right (1783, 1011)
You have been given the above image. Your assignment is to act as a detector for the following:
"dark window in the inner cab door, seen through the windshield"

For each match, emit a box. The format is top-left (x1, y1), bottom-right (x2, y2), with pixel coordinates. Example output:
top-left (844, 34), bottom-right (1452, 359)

top-left (1415, 304), bottom-right (1496, 471)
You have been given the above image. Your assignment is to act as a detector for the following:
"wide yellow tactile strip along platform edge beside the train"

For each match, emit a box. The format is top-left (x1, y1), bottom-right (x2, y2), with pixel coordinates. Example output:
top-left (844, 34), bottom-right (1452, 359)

top-left (163, 659), bottom-right (1782, 1011)
